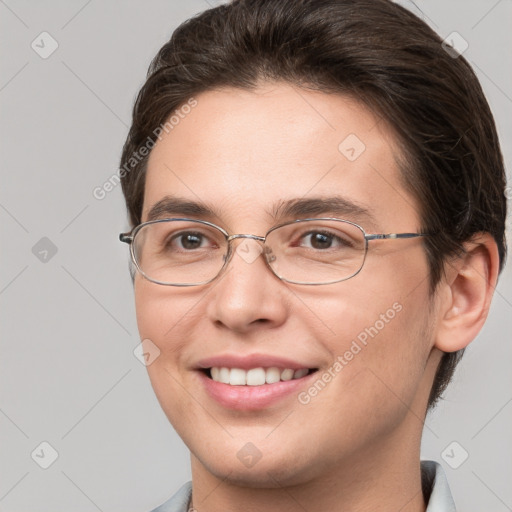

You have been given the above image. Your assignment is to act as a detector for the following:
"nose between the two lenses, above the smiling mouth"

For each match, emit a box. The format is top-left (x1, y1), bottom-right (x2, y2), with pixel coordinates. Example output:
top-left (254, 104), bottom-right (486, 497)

top-left (207, 238), bottom-right (290, 333)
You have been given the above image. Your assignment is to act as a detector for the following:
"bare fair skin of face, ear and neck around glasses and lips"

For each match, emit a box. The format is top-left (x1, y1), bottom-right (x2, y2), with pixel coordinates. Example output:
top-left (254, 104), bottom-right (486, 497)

top-left (135, 83), bottom-right (498, 512)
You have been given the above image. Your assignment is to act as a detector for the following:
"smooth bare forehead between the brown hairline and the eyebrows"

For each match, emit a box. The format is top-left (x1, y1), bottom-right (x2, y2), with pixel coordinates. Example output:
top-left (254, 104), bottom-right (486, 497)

top-left (143, 83), bottom-right (416, 227)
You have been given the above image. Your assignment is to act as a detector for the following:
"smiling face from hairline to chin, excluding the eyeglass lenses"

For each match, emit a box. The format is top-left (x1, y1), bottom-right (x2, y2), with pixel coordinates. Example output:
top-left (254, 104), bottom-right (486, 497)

top-left (135, 83), bottom-right (444, 486)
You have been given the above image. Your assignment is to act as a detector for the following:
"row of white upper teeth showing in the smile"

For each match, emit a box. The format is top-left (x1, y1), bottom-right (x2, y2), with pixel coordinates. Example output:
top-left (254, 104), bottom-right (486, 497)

top-left (210, 366), bottom-right (309, 386)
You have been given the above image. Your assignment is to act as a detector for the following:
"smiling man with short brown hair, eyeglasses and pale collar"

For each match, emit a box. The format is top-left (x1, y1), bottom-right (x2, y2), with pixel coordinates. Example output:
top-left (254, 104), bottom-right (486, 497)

top-left (121, 0), bottom-right (506, 512)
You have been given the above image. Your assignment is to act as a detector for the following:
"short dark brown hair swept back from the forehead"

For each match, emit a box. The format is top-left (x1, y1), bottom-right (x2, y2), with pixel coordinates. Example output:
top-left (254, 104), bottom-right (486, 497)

top-left (121, 0), bottom-right (506, 408)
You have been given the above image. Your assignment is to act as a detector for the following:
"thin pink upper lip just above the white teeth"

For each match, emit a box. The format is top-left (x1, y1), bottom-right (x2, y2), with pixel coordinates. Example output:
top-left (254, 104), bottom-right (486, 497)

top-left (195, 354), bottom-right (318, 370)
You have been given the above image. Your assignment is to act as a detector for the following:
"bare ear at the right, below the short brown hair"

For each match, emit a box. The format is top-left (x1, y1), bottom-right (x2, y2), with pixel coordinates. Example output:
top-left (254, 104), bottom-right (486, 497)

top-left (434, 233), bottom-right (499, 352)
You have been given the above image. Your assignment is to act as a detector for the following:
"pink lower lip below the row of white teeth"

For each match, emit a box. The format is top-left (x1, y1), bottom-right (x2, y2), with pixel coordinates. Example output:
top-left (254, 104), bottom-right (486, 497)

top-left (198, 371), bottom-right (316, 411)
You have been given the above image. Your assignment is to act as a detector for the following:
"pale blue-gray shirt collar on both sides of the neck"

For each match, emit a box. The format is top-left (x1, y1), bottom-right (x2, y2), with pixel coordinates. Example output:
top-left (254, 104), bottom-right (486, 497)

top-left (151, 460), bottom-right (456, 512)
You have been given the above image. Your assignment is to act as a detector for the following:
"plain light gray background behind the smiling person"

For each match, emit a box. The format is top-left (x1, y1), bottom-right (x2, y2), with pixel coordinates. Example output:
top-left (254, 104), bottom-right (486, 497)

top-left (0, 0), bottom-right (512, 512)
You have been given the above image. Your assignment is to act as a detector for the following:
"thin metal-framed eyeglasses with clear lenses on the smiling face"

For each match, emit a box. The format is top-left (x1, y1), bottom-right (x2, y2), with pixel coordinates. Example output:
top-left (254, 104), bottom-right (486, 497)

top-left (119, 218), bottom-right (429, 286)
